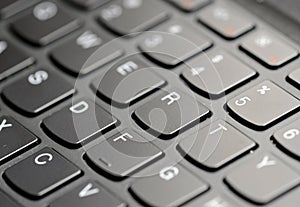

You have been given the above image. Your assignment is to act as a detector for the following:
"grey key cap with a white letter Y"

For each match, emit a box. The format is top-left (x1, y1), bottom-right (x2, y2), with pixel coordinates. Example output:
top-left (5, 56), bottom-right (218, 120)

top-left (226, 154), bottom-right (300, 204)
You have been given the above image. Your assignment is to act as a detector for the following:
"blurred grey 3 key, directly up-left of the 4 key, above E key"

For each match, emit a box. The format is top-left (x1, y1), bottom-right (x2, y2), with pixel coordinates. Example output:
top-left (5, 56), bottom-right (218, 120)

top-left (139, 19), bottom-right (212, 67)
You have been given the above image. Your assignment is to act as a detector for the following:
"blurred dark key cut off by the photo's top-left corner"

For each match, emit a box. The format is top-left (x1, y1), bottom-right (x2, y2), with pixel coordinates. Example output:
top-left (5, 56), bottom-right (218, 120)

top-left (0, 0), bottom-right (39, 19)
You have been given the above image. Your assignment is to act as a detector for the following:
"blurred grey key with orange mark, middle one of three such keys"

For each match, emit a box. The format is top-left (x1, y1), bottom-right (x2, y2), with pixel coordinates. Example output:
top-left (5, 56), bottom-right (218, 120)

top-left (197, 3), bottom-right (255, 40)
